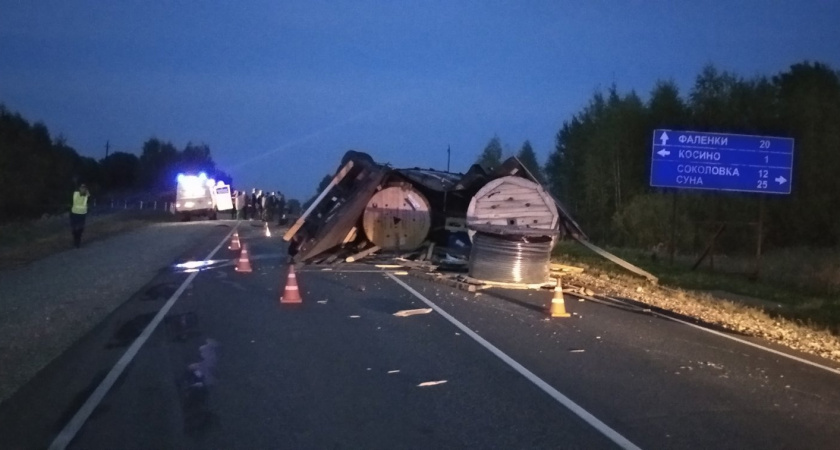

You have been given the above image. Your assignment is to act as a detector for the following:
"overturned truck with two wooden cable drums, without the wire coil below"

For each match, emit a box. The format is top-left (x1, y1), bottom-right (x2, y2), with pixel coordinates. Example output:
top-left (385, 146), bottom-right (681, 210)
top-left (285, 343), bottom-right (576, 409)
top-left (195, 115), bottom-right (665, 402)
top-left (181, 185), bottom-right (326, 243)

top-left (284, 151), bottom-right (585, 263)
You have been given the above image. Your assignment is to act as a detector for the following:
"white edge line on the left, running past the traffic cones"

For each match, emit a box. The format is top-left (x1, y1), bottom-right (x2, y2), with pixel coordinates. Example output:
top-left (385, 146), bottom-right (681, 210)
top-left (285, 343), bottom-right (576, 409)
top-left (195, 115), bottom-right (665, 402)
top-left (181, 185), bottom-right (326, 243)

top-left (49, 221), bottom-right (239, 450)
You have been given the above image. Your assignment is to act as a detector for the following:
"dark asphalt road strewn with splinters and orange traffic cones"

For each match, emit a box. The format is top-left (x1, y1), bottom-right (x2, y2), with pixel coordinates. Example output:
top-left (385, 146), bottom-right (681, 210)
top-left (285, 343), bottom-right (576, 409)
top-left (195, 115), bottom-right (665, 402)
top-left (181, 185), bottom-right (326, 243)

top-left (0, 222), bottom-right (840, 449)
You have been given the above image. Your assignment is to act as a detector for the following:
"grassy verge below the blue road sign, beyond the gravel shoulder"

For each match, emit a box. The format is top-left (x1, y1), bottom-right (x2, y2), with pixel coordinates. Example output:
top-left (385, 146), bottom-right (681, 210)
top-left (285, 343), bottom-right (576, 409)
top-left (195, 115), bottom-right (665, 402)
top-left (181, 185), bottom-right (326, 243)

top-left (553, 241), bottom-right (840, 334)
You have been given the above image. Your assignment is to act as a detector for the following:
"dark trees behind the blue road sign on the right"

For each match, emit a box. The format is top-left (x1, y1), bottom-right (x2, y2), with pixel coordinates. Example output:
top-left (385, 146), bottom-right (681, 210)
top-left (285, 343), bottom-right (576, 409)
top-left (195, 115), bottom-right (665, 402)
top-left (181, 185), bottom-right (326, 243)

top-left (477, 62), bottom-right (840, 251)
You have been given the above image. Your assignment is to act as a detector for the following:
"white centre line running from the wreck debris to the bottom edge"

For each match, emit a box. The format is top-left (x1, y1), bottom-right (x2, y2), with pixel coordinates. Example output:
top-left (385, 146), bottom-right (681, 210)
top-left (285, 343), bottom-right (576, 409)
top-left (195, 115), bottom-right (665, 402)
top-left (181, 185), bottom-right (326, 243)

top-left (387, 273), bottom-right (640, 450)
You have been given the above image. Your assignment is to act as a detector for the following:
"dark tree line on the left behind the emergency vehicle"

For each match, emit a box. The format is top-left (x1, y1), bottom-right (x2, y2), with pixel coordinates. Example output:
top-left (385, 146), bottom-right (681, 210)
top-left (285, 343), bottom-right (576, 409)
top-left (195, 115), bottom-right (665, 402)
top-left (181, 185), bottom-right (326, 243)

top-left (0, 105), bottom-right (226, 220)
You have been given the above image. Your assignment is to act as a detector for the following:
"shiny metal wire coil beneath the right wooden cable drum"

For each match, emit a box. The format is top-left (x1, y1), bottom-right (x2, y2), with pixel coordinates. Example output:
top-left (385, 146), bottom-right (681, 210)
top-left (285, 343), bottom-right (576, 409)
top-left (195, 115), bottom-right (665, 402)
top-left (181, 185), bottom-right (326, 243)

top-left (470, 232), bottom-right (551, 284)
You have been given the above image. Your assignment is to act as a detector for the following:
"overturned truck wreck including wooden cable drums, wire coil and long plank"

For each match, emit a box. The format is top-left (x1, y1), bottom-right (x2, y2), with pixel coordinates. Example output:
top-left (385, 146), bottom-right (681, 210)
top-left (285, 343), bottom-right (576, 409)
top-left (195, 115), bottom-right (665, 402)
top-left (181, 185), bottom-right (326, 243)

top-left (283, 150), bottom-right (657, 284)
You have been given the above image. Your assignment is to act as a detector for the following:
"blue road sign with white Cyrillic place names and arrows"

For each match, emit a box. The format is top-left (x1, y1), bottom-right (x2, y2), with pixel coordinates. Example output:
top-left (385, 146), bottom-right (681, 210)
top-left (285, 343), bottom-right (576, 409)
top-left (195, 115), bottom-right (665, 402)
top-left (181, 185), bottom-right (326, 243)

top-left (650, 130), bottom-right (793, 194)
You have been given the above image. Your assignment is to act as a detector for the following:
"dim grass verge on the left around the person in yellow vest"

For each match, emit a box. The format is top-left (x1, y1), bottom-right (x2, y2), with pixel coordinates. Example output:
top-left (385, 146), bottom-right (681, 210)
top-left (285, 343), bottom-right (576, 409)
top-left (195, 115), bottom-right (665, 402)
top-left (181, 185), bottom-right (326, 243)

top-left (0, 210), bottom-right (175, 270)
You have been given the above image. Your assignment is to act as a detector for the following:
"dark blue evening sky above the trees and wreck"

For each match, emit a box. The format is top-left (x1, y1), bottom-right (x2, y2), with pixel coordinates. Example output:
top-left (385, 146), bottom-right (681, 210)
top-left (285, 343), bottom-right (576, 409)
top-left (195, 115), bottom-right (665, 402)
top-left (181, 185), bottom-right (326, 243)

top-left (0, 0), bottom-right (840, 199)
